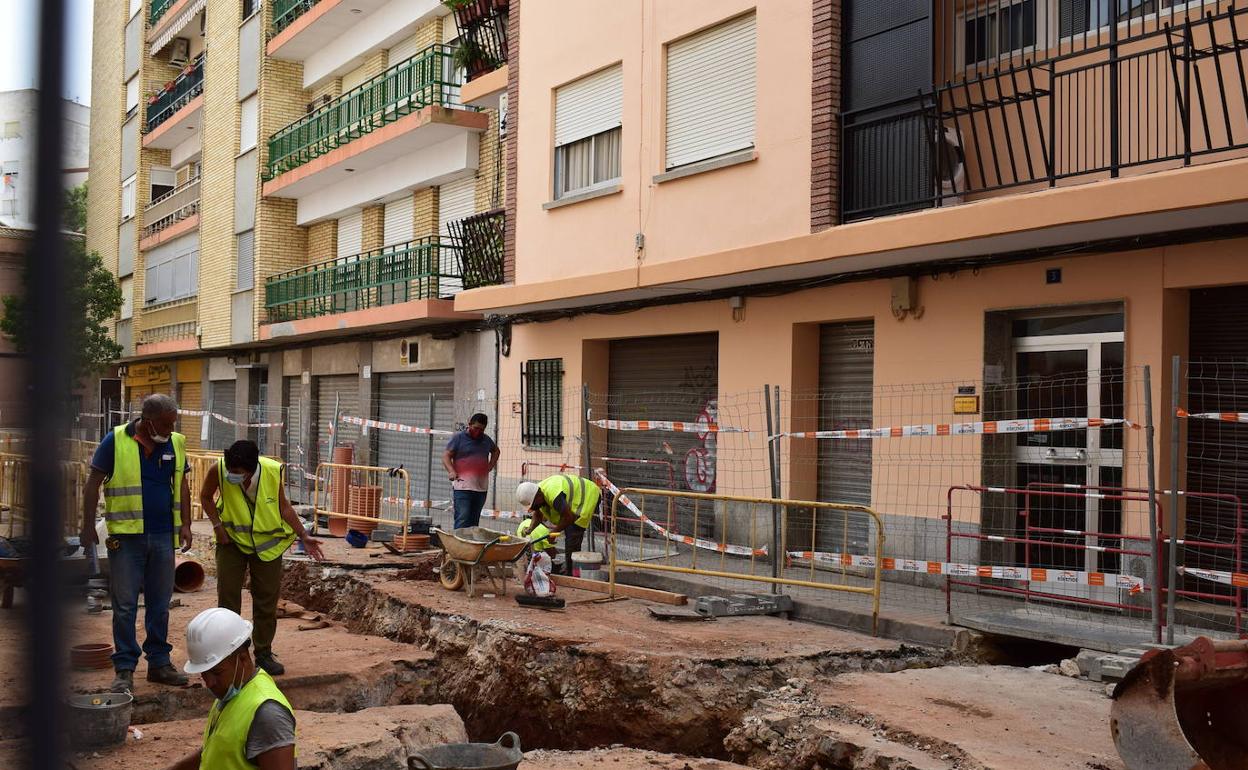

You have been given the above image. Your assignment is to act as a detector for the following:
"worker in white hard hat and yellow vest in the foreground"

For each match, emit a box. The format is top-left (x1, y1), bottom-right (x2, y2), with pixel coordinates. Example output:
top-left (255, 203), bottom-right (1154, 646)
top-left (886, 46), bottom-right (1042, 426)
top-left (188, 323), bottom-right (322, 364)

top-left (165, 607), bottom-right (296, 770)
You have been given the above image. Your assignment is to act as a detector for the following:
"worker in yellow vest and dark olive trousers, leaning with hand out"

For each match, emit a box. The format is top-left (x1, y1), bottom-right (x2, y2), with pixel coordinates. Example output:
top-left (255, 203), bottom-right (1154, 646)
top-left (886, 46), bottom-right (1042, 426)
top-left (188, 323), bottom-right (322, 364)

top-left (200, 439), bottom-right (324, 676)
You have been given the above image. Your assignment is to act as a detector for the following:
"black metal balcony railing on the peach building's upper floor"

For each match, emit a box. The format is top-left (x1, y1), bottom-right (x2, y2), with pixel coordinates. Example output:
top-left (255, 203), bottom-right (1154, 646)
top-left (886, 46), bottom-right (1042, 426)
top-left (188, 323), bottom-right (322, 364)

top-left (840, 0), bottom-right (1248, 221)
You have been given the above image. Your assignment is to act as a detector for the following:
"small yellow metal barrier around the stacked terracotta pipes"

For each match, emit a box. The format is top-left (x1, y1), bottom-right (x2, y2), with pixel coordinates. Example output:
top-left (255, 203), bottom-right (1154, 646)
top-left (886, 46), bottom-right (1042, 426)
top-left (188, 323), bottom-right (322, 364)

top-left (312, 463), bottom-right (414, 534)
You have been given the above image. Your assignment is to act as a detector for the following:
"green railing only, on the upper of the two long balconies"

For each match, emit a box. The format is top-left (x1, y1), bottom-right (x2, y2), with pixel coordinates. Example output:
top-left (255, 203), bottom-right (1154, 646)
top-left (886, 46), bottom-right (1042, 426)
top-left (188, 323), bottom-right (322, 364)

top-left (265, 45), bottom-right (468, 180)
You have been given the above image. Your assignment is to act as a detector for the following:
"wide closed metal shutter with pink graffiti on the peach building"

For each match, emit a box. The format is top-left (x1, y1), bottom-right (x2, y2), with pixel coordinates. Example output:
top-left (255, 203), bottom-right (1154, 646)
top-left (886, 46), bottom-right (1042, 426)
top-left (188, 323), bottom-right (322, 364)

top-left (606, 334), bottom-right (719, 534)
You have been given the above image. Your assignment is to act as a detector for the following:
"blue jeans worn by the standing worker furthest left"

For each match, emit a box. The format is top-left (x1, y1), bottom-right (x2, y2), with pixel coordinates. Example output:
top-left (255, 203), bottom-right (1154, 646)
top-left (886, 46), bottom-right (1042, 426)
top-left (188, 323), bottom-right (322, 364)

top-left (109, 533), bottom-right (173, 671)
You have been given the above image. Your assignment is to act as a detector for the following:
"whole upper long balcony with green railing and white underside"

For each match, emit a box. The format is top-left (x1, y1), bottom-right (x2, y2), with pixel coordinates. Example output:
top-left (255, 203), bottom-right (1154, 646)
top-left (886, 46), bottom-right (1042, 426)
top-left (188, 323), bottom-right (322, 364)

top-left (263, 45), bottom-right (489, 225)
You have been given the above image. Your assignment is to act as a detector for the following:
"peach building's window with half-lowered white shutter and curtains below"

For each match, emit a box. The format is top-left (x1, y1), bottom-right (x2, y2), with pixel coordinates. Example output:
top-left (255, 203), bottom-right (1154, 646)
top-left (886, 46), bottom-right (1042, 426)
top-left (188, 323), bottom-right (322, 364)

top-left (554, 65), bottom-right (624, 200)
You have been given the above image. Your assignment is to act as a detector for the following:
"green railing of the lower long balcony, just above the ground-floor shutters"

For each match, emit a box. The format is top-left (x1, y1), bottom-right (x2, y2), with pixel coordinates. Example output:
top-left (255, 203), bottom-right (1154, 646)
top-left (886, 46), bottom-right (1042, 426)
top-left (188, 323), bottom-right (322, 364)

top-left (265, 238), bottom-right (463, 323)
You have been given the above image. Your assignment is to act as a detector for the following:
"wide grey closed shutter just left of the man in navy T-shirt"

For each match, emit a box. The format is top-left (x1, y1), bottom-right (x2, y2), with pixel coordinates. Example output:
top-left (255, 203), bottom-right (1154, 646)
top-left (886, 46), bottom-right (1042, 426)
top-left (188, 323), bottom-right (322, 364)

top-left (376, 369), bottom-right (456, 511)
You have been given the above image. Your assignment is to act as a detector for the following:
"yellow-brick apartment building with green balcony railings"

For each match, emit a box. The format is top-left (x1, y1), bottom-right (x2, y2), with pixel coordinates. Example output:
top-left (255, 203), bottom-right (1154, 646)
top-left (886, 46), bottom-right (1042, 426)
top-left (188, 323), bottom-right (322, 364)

top-left (87, 0), bottom-right (505, 499)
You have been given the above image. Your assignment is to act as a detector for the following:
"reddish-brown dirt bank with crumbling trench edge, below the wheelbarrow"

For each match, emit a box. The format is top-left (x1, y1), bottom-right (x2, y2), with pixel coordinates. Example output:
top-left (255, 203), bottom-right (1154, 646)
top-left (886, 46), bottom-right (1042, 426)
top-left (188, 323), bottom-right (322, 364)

top-left (283, 564), bottom-right (945, 759)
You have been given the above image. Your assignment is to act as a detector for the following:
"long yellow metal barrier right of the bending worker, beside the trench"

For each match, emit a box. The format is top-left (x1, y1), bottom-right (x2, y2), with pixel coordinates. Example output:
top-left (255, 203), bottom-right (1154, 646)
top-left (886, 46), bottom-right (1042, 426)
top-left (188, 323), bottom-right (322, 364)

top-left (608, 485), bottom-right (885, 634)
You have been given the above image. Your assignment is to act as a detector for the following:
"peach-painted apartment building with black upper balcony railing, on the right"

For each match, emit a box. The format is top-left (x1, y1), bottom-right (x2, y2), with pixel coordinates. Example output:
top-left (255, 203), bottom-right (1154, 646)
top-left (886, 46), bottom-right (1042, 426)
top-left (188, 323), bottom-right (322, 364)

top-left (456, 0), bottom-right (1248, 631)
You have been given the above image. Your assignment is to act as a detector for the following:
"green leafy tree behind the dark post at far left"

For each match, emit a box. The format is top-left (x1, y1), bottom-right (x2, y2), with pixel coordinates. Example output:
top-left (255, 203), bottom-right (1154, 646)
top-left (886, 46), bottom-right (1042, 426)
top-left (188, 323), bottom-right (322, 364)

top-left (0, 238), bottom-right (121, 381)
